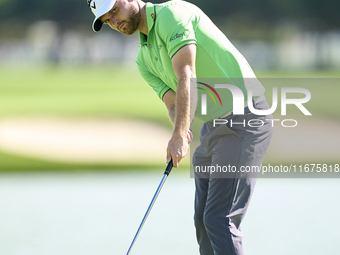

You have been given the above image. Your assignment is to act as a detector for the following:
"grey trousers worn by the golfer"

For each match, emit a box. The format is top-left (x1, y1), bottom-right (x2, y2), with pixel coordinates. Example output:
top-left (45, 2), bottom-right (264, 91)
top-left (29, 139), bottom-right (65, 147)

top-left (193, 101), bottom-right (272, 255)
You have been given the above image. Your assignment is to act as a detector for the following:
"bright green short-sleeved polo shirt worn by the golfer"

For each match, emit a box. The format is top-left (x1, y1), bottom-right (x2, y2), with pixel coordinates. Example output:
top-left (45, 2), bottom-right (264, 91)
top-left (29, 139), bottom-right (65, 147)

top-left (136, 1), bottom-right (264, 121)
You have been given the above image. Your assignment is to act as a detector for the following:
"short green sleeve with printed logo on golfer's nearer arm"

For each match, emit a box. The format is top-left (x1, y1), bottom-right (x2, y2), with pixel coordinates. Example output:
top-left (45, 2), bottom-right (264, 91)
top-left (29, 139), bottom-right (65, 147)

top-left (157, 7), bottom-right (196, 58)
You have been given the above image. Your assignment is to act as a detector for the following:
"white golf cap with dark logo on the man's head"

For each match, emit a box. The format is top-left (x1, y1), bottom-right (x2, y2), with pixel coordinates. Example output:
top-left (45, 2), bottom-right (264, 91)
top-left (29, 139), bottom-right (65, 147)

top-left (87, 0), bottom-right (116, 32)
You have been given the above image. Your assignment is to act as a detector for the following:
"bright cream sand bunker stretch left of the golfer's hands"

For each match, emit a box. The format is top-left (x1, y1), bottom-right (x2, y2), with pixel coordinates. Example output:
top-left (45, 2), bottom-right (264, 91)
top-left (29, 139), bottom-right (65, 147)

top-left (0, 118), bottom-right (171, 163)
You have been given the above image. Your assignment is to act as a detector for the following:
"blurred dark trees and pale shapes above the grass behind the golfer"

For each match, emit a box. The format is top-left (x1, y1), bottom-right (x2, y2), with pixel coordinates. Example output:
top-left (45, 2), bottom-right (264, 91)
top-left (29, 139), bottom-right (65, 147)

top-left (0, 0), bottom-right (340, 70)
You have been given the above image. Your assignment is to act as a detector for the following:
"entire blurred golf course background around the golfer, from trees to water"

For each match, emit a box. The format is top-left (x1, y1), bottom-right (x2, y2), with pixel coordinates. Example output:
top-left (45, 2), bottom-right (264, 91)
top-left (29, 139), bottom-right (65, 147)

top-left (0, 0), bottom-right (340, 255)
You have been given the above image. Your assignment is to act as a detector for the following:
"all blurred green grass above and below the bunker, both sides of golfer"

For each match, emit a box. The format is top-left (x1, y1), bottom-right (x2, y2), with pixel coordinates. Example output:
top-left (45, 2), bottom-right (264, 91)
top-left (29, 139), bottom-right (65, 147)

top-left (0, 66), bottom-right (340, 171)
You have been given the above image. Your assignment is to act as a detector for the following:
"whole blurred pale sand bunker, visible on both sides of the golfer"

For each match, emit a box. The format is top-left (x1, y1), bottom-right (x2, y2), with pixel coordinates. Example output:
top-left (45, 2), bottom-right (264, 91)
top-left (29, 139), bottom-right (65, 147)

top-left (0, 118), bottom-right (340, 164)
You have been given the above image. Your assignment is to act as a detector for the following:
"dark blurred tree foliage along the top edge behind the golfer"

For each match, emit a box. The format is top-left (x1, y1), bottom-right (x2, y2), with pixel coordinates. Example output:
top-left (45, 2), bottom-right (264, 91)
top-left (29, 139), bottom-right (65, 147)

top-left (0, 0), bottom-right (340, 35)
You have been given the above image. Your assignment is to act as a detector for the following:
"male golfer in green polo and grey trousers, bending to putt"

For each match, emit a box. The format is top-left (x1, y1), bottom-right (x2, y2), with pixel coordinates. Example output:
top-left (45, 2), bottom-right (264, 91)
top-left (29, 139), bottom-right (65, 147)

top-left (88, 0), bottom-right (272, 255)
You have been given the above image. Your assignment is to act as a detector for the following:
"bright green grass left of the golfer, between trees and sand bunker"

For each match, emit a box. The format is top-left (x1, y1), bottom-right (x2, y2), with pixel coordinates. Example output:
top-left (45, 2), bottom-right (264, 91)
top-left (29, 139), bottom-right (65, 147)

top-left (0, 66), bottom-right (168, 124)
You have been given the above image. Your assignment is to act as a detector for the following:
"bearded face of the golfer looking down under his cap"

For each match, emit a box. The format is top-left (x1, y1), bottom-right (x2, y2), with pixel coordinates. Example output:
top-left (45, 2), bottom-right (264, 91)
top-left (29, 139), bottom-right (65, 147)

top-left (100, 0), bottom-right (141, 35)
